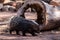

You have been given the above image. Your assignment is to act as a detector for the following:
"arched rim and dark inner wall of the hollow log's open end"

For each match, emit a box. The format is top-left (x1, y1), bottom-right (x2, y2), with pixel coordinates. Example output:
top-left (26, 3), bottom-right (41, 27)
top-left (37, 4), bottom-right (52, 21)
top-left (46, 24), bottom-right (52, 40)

top-left (19, 1), bottom-right (46, 25)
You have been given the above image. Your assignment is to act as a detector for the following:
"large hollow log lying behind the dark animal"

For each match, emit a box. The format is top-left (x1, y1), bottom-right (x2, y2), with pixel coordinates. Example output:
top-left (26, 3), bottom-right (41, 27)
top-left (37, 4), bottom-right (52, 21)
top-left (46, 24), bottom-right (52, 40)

top-left (17, 0), bottom-right (60, 31)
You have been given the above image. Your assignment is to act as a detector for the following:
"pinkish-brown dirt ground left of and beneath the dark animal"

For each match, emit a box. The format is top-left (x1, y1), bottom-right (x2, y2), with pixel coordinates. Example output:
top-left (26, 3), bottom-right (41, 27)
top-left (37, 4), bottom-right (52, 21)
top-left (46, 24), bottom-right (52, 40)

top-left (0, 12), bottom-right (60, 40)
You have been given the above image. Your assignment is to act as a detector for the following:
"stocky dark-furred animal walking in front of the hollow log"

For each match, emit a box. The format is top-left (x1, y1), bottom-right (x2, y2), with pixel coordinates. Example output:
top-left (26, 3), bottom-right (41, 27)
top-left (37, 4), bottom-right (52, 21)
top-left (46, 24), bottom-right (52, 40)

top-left (10, 16), bottom-right (39, 36)
